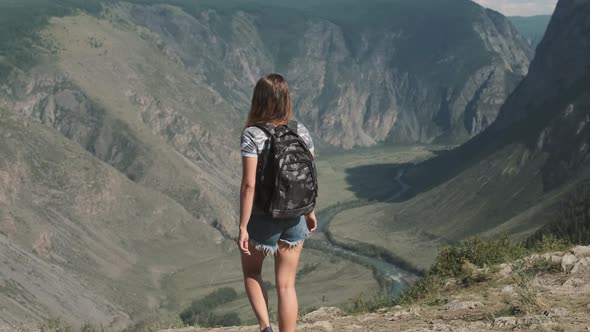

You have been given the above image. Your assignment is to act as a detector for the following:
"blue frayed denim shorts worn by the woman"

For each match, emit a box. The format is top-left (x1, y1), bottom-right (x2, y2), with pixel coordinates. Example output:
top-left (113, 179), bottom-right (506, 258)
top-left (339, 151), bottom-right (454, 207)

top-left (248, 214), bottom-right (309, 255)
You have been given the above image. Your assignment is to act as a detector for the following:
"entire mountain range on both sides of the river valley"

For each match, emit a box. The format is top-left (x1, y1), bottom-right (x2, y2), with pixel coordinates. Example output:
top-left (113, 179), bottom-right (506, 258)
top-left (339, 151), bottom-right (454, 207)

top-left (0, 0), bottom-right (590, 329)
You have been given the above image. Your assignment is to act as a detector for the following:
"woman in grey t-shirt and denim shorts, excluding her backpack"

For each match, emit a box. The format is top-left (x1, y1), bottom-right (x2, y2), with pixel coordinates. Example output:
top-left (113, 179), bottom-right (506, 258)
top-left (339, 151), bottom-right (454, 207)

top-left (238, 74), bottom-right (317, 332)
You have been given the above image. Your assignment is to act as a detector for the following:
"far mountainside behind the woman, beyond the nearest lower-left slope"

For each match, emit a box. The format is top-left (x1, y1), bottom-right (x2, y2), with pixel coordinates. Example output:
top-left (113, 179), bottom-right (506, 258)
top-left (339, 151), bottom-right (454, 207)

top-left (0, 0), bottom-right (532, 253)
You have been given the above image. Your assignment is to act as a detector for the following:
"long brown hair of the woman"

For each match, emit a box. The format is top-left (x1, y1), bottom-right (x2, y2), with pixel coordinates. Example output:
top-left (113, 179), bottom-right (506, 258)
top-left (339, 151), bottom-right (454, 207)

top-left (246, 74), bottom-right (293, 126)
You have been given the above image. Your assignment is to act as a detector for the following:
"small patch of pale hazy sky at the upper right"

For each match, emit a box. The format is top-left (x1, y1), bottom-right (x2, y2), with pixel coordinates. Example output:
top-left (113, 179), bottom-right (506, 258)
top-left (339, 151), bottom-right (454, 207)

top-left (473, 0), bottom-right (557, 16)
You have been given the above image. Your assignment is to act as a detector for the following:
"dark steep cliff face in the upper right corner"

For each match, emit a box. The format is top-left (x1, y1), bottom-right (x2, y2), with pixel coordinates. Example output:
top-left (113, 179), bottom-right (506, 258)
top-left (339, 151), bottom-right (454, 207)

top-left (491, 0), bottom-right (590, 191)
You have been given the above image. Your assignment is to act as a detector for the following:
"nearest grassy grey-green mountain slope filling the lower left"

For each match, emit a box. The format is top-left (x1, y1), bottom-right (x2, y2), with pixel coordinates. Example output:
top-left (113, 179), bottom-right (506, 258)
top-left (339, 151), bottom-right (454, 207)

top-left (0, 110), bottom-right (227, 330)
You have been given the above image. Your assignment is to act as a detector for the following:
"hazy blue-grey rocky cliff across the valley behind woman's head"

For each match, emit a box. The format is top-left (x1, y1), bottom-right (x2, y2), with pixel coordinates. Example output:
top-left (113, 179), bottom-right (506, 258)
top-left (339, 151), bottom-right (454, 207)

top-left (129, 1), bottom-right (532, 148)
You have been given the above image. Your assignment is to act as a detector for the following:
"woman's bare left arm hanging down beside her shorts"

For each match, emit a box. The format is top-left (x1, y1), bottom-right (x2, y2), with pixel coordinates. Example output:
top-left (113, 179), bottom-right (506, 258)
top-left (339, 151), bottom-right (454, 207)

top-left (239, 157), bottom-right (258, 255)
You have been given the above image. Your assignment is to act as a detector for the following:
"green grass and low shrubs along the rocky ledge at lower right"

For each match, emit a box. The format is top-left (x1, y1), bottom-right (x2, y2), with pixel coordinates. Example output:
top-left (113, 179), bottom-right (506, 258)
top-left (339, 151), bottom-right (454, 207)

top-left (343, 236), bottom-right (571, 314)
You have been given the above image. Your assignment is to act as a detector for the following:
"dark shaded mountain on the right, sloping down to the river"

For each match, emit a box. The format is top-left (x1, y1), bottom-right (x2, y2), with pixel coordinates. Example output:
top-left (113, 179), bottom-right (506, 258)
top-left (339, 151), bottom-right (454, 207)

top-left (330, 0), bottom-right (590, 267)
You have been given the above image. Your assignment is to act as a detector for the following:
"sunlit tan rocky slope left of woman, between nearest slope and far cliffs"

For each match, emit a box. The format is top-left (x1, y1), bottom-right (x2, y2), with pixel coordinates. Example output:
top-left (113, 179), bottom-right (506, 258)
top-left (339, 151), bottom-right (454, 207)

top-left (0, 12), bottom-right (242, 234)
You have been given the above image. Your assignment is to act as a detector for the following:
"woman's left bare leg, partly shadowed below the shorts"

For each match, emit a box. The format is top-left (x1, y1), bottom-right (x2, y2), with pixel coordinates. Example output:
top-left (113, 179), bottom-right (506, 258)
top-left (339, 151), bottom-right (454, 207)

top-left (242, 246), bottom-right (270, 330)
